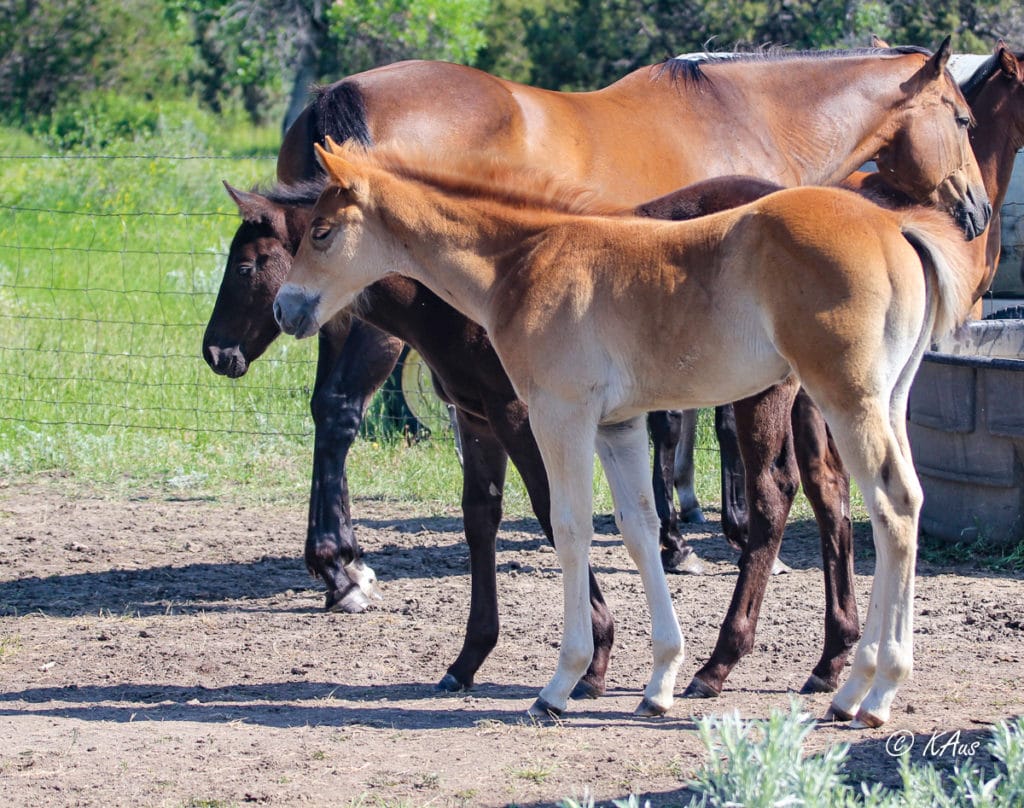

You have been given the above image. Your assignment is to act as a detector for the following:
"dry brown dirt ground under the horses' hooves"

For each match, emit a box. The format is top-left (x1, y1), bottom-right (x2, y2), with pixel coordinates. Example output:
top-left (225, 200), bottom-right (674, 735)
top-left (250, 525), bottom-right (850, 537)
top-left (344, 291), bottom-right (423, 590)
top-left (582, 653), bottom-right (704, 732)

top-left (0, 485), bottom-right (1024, 808)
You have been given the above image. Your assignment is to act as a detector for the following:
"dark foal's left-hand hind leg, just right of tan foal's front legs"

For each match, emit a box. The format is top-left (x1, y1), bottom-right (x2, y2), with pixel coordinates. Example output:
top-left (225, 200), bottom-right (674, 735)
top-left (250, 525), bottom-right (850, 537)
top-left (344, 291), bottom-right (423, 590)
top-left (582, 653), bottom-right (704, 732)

top-left (684, 378), bottom-right (800, 698)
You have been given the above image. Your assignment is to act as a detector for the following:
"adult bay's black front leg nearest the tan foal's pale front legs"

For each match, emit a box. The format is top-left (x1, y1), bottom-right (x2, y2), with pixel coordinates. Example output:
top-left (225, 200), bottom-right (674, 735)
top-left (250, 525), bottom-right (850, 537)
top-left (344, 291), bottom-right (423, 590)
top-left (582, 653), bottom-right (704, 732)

top-left (647, 410), bottom-right (703, 575)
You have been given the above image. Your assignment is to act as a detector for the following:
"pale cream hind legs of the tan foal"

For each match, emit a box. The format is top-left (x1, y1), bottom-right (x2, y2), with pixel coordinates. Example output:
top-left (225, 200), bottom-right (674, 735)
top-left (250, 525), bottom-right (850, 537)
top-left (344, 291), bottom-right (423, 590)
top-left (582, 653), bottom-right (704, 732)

top-left (828, 400), bottom-right (924, 727)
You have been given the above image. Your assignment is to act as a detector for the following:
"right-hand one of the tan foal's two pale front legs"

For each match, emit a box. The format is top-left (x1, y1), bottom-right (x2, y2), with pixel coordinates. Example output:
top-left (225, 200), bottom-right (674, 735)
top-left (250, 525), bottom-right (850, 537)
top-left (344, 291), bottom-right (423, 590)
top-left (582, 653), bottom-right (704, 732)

top-left (597, 418), bottom-right (683, 716)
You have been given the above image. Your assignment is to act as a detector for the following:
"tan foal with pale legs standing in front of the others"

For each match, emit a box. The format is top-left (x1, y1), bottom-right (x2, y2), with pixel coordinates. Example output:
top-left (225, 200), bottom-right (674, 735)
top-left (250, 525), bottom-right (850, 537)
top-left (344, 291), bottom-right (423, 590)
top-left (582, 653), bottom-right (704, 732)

top-left (274, 141), bottom-right (976, 726)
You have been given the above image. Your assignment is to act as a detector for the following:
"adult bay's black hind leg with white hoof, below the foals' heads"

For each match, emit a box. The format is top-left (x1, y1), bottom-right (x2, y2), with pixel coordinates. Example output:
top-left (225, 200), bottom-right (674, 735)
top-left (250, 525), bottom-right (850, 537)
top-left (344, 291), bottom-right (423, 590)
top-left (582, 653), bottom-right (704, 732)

top-left (305, 320), bottom-right (401, 613)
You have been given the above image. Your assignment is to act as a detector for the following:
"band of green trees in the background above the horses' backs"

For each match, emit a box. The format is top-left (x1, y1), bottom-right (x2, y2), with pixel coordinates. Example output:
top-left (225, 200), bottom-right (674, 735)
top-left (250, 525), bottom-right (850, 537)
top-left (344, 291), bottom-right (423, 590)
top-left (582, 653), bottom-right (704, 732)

top-left (0, 0), bottom-right (1024, 132)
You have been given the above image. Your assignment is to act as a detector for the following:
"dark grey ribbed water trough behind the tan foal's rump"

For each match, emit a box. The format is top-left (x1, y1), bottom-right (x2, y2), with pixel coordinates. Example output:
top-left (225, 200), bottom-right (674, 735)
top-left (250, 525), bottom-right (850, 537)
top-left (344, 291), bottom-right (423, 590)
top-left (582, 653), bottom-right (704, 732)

top-left (908, 320), bottom-right (1024, 543)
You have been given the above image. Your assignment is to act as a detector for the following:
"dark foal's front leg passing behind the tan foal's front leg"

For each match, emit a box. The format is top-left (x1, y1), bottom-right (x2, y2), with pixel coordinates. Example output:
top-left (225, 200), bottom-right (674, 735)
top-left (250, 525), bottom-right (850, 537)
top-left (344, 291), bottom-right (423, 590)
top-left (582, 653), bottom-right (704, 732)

top-left (485, 397), bottom-right (615, 698)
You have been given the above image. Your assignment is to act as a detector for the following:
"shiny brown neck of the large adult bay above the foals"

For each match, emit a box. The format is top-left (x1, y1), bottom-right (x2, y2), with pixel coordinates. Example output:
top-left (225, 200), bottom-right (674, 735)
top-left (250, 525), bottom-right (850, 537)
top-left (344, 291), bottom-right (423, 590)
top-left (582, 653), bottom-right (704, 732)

top-left (643, 55), bottom-right (922, 184)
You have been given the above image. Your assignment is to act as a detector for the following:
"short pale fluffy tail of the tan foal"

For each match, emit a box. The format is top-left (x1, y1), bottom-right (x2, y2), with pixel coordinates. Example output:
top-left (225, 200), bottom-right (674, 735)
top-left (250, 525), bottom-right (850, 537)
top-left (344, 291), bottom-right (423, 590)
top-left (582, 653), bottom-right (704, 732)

top-left (900, 208), bottom-right (978, 340)
